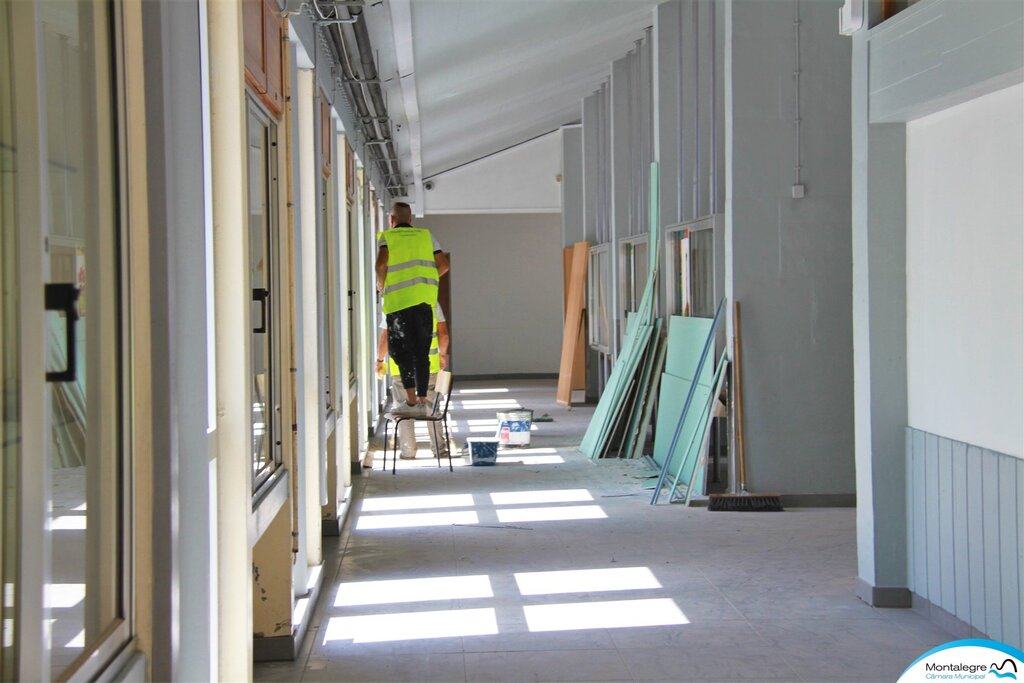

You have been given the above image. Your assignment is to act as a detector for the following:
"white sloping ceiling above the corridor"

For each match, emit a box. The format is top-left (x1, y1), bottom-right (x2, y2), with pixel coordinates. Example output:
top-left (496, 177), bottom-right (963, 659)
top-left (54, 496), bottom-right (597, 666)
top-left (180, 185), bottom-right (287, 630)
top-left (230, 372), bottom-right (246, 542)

top-left (365, 0), bottom-right (657, 202)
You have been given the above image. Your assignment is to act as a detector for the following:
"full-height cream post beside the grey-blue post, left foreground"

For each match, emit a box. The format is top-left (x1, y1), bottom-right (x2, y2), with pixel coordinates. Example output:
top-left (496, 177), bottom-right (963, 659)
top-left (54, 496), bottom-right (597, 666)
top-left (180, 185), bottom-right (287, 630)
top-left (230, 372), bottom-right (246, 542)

top-left (207, 2), bottom-right (253, 681)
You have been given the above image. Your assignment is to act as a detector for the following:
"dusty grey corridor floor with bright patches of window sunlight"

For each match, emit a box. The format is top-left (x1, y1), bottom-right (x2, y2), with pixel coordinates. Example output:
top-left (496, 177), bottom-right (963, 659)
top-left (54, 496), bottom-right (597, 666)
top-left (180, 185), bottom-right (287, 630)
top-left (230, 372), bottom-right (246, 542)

top-left (255, 382), bottom-right (954, 682)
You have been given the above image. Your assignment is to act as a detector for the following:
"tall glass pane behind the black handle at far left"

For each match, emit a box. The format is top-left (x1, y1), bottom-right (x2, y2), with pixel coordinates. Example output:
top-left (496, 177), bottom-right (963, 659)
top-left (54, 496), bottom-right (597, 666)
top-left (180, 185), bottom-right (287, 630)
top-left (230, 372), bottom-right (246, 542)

top-left (37, 2), bottom-right (123, 676)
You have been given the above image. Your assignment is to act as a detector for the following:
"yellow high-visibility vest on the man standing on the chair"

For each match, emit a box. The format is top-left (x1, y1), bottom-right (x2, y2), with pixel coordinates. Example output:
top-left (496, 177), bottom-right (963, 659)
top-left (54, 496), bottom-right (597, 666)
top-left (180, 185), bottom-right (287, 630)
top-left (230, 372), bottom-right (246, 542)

top-left (382, 227), bottom-right (439, 313)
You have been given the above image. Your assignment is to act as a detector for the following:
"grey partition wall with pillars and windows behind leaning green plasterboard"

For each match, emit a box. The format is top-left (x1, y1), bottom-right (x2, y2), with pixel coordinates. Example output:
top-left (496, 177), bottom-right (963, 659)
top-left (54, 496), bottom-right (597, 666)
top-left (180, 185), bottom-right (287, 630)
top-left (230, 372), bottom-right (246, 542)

top-left (562, 0), bottom-right (854, 505)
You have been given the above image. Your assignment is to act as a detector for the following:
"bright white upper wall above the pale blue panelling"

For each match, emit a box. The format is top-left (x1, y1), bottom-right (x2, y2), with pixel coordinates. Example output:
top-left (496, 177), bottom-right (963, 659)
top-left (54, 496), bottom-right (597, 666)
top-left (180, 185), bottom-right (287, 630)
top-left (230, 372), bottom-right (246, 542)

top-left (906, 85), bottom-right (1024, 458)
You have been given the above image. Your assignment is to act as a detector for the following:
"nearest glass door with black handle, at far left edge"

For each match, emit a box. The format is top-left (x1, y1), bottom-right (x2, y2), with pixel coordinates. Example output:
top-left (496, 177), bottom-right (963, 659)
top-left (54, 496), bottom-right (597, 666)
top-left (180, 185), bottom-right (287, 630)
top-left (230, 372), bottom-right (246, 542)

top-left (0, 1), bottom-right (131, 680)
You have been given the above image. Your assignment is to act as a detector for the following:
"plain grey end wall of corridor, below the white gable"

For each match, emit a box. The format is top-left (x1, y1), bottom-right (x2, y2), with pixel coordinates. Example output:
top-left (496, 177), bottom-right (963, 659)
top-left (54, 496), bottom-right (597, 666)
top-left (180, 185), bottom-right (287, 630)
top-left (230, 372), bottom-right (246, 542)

top-left (416, 213), bottom-right (562, 377)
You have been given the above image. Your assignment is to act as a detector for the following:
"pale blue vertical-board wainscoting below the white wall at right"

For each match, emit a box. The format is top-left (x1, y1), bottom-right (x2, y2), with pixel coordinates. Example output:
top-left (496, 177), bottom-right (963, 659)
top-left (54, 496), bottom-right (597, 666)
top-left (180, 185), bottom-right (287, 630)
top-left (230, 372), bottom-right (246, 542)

top-left (906, 427), bottom-right (1024, 647)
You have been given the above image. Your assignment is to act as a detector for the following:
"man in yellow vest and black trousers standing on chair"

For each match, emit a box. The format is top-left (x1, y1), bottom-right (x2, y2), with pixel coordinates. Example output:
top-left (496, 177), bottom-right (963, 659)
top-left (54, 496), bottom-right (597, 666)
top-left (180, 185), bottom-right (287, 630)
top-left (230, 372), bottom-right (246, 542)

top-left (375, 202), bottom-right (449, 415)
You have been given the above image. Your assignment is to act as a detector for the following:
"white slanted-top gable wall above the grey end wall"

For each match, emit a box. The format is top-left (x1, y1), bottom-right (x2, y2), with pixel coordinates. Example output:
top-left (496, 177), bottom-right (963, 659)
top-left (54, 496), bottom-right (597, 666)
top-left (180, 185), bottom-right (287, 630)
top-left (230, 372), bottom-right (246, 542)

top-left (423, 130), bottom-right (562, 210)
